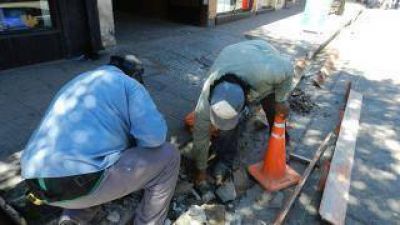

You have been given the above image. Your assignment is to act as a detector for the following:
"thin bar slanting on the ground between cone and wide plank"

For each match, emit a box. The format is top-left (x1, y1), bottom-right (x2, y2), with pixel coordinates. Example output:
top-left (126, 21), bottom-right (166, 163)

top-left (273, 131), bottom-right (334, 225)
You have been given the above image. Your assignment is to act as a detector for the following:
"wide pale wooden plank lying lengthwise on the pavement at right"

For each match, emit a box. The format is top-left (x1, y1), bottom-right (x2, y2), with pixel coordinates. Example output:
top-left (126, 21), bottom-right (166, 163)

top-left (319, 90), bottom-right (363, 225)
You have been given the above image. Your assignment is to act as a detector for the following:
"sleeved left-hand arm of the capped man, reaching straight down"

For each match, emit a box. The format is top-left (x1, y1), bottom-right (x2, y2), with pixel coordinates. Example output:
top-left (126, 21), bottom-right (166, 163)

top-left (193, 91), bottom-right (211, 184)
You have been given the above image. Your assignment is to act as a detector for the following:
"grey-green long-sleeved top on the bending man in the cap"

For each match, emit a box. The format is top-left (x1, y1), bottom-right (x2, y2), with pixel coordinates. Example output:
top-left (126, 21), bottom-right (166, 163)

top-left (192, 40), bottom-right (294, 170)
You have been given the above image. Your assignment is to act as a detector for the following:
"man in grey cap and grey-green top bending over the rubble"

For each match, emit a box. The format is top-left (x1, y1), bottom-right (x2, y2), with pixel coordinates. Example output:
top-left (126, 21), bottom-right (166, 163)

top-left (192, 40), bottom-right (294, 189)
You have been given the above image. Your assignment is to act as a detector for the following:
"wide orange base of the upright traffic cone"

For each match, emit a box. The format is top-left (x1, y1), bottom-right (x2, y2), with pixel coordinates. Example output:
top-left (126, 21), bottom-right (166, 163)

top-left (249, 162), bottom-right (301, 192)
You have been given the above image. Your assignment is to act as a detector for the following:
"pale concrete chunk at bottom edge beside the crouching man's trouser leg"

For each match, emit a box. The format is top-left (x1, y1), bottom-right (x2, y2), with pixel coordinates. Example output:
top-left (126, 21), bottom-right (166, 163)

top-left (174, 205), bottom-right (208, 225)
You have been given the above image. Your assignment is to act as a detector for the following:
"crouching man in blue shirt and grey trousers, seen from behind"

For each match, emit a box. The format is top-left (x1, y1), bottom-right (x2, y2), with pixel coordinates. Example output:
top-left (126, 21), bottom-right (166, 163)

top-left (21, 55), bottom-right (180, 225)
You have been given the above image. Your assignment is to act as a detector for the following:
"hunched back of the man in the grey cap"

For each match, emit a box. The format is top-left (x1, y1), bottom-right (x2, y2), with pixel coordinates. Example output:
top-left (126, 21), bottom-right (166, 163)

top-left (209, 40), bottom-right (294, 103)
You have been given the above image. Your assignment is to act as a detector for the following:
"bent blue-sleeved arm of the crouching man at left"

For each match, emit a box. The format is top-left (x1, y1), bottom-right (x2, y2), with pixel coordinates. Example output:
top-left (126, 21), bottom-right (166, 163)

top-left (128, 83), bottom-right (167, 148)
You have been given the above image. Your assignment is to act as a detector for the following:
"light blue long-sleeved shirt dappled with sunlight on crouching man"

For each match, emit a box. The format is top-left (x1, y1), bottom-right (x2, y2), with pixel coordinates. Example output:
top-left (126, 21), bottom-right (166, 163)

top-left (21, 66), bottom-right (167, 179)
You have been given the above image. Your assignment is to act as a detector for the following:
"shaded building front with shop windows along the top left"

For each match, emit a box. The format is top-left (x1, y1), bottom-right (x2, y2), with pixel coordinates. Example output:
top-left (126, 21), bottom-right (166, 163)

top-left (0, 0), bottom-right (284, 70)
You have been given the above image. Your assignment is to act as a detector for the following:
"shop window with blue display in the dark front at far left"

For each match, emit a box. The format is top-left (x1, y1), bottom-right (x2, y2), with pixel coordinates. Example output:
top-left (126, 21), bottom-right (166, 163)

top-left (0, 0), bottom-right (53, 34)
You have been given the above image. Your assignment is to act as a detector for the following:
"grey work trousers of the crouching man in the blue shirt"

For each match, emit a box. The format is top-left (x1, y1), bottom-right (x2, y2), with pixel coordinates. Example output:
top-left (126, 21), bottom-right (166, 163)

top-left (50, 144), bottom-right (180, 225)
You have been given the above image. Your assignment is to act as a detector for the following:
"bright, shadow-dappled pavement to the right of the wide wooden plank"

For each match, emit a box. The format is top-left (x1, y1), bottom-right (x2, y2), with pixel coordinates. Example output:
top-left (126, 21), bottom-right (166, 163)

top-left (336, 10), bottom-right (400, 225)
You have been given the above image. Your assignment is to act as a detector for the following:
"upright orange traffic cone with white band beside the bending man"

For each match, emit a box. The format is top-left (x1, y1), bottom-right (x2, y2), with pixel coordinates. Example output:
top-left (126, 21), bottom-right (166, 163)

top-left (249, 115), bottom-right (300, 191)
